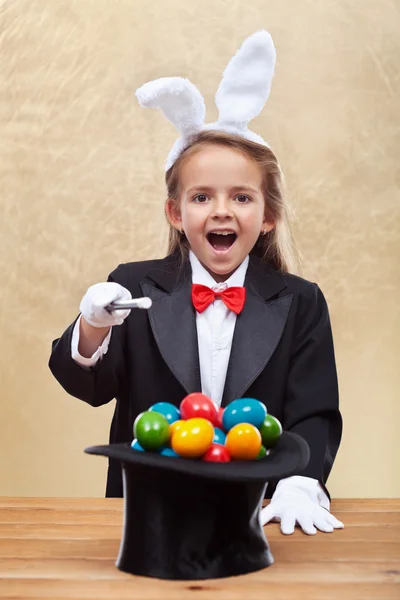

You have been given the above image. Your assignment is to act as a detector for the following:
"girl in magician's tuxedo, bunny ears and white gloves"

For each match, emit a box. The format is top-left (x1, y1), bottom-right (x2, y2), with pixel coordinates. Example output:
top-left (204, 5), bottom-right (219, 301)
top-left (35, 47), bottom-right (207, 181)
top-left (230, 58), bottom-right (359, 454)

top-left (50, 32), bottom-right (343, 534)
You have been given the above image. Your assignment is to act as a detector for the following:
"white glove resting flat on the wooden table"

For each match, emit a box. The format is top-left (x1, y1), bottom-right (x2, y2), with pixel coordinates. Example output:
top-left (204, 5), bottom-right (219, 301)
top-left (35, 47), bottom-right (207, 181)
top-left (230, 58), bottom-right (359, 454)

top-left (260, 476), bottom-right (344, 535)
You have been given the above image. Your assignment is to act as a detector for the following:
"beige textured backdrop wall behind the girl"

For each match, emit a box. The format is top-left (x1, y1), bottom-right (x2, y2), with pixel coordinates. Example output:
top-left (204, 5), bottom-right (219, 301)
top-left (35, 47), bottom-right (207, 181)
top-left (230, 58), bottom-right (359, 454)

top-left (0, 0), bottom-right (400, 497)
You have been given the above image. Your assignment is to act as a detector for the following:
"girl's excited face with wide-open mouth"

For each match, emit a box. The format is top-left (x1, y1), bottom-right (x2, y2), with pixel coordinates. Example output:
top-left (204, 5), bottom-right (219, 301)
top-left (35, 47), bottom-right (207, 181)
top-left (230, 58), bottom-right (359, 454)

top-left (167, 145), bottom-right (274, 281)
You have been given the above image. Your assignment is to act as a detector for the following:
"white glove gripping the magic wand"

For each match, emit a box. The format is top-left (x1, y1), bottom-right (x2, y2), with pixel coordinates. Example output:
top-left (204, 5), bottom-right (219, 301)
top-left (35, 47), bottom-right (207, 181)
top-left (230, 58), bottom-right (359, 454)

top-left (79, 281), bottom-right (132, 327)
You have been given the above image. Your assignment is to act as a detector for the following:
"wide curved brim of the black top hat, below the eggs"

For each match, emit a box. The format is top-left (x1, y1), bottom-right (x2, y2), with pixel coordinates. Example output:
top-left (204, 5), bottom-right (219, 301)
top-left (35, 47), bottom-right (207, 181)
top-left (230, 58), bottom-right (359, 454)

top-left (85, 432), bottom-right (310, 482)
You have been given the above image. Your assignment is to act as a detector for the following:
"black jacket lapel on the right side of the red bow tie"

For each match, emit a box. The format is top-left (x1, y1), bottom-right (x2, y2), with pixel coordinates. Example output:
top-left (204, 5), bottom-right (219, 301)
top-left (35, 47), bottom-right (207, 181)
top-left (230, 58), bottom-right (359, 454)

top-left (222, 257), bottom-right (292, 406)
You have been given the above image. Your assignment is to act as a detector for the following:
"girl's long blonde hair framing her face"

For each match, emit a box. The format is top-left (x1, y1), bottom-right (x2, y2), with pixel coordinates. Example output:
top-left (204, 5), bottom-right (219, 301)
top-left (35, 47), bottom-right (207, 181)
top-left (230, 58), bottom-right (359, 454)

top-left (165, 131), bottom-right (299, 273)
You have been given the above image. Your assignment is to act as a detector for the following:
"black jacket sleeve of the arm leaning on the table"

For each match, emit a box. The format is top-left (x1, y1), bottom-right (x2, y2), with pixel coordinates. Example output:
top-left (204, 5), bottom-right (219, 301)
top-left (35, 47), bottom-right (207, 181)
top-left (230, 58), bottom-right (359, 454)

top-left (283, 284), bottom-right (342, 491)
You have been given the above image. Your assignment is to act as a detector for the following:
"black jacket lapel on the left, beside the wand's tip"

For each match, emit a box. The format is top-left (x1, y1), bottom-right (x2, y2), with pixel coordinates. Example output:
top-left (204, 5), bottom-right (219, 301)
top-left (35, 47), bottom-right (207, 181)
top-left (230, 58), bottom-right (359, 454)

top-left (141, 257), bottom-right (201, 394)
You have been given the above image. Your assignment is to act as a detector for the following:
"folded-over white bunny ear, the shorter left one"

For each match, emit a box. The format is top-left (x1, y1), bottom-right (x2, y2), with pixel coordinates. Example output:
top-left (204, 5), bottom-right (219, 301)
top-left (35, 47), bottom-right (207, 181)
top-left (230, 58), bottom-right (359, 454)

top-left (136, 77), bottom-right (206, 136)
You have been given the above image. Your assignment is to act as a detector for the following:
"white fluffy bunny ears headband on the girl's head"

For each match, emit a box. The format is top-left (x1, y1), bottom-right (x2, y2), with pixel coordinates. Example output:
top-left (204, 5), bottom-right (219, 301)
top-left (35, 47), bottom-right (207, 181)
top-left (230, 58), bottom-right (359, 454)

top-left (136, 30), bottom-right (276, 171)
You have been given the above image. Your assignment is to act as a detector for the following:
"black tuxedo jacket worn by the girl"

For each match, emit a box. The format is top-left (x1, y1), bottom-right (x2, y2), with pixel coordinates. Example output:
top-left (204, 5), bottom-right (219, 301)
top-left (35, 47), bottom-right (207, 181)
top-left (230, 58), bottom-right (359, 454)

top-left (49, 255), bottom-right (342, 497)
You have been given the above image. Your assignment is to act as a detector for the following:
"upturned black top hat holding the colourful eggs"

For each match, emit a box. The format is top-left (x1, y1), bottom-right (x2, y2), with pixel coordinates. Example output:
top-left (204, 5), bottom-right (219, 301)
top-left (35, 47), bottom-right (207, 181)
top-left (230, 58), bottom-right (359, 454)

top-left (85, 432), bottom-right (309, 580)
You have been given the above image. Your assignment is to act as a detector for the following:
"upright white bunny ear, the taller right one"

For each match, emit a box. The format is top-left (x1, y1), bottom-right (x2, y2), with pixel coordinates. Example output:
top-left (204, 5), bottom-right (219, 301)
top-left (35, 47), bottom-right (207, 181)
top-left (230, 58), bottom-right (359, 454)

top-left (215, 30), bottom-right (276, 130)
